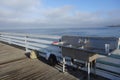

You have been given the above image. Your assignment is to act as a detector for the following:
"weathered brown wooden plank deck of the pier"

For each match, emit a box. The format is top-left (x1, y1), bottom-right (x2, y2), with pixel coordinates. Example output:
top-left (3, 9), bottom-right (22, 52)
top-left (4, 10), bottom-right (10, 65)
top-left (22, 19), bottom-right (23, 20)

top-left (0, 42), bottom-right (109, 80)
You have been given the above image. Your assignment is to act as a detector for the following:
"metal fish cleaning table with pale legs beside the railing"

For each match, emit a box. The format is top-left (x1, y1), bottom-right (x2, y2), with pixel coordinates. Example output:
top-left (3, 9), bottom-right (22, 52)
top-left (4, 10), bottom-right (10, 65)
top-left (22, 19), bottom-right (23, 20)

top-left (54, 36), bottom-right (119, 80)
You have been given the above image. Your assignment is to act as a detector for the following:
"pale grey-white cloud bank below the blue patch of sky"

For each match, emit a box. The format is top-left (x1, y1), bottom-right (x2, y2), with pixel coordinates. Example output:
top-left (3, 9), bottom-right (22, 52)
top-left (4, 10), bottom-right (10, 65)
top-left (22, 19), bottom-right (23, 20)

top-left (0, 0), bottom-right (120, 29)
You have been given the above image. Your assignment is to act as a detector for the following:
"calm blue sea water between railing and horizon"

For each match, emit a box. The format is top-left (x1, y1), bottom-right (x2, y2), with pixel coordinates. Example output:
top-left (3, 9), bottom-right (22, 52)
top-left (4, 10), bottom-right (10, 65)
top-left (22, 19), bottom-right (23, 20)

top-left (0, 27), bottom-right (120, 37)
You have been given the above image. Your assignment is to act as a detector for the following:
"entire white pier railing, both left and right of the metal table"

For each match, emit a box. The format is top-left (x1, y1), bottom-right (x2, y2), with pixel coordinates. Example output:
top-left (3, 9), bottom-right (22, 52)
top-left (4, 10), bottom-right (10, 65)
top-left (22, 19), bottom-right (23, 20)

top-left (0, 32), bottom-right (120, 80)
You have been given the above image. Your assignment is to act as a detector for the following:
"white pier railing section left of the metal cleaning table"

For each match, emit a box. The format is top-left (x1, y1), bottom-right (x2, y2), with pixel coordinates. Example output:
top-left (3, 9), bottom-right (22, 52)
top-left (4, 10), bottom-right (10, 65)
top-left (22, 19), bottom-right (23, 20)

top-left (0, 33), bottom-right (60, 52)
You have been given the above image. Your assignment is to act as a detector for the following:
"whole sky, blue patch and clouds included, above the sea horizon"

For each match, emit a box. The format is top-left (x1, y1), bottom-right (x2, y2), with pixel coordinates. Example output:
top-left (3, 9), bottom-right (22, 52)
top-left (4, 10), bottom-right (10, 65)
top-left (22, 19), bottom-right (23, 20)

top-left (0, 0), bottom-right (120, 29)
